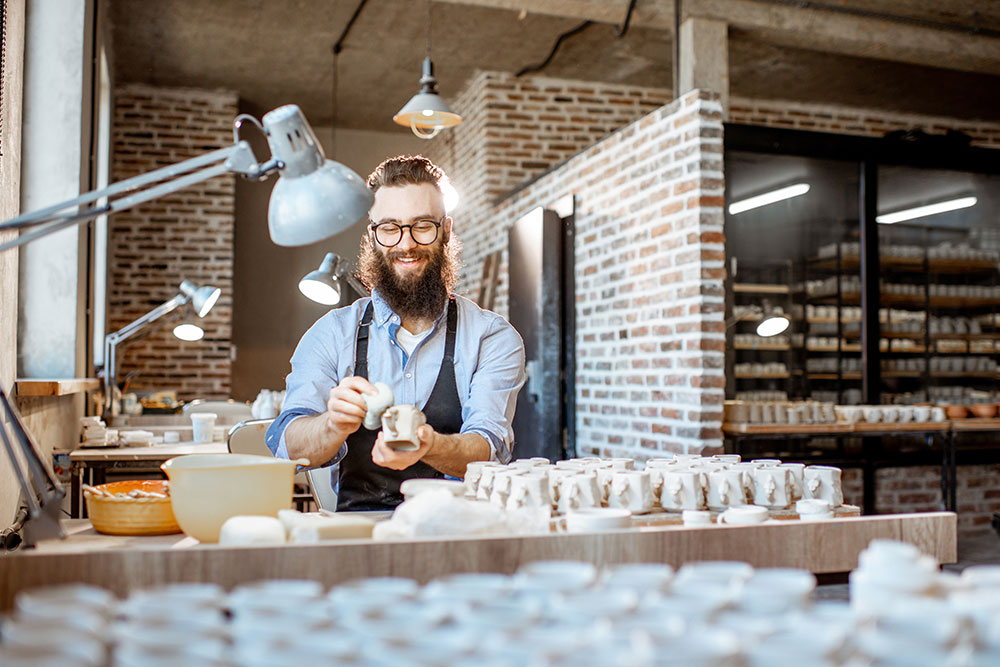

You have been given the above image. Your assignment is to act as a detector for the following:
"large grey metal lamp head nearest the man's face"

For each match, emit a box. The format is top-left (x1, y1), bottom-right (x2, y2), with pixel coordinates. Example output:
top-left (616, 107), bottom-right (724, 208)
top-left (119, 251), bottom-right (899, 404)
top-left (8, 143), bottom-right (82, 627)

top-left (261, 104), bottom-right (374, 246)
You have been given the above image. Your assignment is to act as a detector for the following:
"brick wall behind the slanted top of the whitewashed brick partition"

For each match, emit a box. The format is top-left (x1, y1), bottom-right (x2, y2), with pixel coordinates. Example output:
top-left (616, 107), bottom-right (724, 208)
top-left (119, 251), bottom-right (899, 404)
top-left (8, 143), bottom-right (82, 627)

top-left (425, 71), bottom-right (671, 306)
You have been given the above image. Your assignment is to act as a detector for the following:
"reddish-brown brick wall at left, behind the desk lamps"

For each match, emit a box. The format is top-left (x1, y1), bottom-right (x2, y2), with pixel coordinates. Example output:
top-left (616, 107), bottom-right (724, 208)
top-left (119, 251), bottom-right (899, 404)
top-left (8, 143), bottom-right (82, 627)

top-left (108, 85), bottom-right (237, 399)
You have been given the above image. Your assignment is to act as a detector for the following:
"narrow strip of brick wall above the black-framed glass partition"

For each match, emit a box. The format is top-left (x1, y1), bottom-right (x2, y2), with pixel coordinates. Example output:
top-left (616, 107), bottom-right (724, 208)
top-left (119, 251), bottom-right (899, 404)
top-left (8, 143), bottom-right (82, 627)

top-left (727, 98), bottom-right (1000, 148)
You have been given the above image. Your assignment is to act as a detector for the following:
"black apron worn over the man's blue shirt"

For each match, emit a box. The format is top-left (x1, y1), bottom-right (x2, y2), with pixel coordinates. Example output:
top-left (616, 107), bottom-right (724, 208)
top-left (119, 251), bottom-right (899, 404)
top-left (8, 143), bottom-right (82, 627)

top-left (337, 297), bottom-right (462, 512)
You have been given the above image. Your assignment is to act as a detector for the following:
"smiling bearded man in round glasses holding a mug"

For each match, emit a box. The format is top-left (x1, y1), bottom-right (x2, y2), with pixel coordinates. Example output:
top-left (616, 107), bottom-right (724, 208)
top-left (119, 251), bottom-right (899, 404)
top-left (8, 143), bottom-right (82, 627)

top-left (267, 156), bottom-right (525, 511)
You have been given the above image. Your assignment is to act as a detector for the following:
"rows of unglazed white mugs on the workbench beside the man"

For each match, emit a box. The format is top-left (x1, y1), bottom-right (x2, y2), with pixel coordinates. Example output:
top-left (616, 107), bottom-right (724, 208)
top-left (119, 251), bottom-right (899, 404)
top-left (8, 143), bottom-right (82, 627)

top-left (465, 454), bottom-right (844, 514)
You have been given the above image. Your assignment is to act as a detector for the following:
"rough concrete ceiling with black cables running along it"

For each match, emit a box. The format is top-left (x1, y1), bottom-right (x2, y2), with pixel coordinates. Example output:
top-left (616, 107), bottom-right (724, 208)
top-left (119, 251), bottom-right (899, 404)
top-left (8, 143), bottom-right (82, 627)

top-left (107, 0), bottom-right (1000, 131)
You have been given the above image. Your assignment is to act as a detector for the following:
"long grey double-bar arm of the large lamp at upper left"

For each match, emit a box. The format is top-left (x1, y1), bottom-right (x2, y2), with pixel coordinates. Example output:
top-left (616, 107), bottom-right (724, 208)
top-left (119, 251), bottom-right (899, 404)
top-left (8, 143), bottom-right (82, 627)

top-left (0, 141), bottom-right (270, 252)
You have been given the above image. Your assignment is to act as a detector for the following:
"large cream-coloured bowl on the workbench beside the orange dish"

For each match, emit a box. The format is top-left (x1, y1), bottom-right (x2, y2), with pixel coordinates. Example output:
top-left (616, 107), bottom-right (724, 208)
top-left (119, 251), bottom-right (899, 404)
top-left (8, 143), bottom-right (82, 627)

top-left (160, 454), bottom-right (309, 542)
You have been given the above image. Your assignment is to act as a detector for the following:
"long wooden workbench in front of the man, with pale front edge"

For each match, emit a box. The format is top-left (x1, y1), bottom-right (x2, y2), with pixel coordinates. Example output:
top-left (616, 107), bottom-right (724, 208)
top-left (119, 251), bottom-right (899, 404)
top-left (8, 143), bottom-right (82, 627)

top-left (0, 512), bottom-right (957, 609)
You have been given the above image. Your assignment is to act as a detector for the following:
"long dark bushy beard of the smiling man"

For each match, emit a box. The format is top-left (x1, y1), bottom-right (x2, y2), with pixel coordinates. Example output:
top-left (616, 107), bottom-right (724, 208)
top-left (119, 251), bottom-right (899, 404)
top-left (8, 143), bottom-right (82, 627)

top-left (358, 234), bottom-right (461, 319)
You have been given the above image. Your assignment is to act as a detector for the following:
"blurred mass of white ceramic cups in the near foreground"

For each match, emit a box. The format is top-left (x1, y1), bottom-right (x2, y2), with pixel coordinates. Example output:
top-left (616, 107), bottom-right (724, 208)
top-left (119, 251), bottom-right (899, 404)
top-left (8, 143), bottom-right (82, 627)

top-left (0, 542), bottom-right (984, 667)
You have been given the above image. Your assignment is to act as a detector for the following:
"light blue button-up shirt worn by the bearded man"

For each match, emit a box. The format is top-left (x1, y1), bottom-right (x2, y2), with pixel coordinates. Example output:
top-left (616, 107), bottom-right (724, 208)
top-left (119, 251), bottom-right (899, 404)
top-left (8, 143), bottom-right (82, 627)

top-left (267, 291), bottom-right (525, 463)
